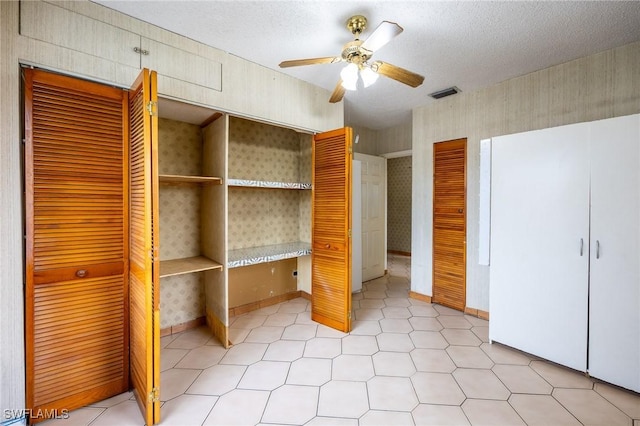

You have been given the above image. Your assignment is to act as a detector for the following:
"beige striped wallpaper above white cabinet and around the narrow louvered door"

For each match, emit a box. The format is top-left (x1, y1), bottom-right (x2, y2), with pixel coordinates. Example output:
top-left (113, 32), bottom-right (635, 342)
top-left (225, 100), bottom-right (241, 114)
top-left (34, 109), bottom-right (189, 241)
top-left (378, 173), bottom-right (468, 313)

top-left (411, 42), bottom-right (640, 311)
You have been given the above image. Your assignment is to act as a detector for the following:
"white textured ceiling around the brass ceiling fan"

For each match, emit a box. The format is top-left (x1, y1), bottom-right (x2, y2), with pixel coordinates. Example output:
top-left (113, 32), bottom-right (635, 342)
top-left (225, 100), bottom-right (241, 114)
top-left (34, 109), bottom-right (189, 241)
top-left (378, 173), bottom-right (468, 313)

top-left (96, 0), bottom-right (640, 129)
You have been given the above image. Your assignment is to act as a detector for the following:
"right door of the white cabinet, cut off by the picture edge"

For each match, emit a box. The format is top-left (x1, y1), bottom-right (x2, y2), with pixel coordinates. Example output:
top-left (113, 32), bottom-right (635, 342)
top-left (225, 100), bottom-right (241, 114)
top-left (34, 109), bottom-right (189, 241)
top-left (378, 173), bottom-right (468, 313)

top-left (589, 115), bottom-right (640, 392)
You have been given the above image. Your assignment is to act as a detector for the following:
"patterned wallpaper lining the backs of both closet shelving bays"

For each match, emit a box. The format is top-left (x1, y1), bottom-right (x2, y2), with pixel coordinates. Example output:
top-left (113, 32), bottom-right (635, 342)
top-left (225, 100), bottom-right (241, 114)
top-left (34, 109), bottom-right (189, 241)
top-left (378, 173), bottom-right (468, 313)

top-left (158, 118), bottom-right (311, 328)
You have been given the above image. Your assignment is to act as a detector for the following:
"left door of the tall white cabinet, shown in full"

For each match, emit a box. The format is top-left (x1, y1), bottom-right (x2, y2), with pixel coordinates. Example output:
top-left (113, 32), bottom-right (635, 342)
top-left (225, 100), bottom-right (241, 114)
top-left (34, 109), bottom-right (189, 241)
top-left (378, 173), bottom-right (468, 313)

top-left (489, 124), bottom-right (589, 371)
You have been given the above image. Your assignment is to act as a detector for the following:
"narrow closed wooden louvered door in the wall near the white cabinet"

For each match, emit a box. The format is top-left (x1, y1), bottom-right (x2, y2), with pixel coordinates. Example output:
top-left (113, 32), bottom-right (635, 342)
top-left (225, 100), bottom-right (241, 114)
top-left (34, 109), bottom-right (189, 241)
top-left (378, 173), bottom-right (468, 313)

top-left (433, 139), bottom-right (467, 311)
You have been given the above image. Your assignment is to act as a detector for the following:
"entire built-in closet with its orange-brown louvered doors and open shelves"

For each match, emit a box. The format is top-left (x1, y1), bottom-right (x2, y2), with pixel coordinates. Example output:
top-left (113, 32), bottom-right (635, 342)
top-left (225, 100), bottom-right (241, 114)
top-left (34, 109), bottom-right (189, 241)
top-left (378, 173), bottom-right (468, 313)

top-left (25, 65), bottom-right (351, 424)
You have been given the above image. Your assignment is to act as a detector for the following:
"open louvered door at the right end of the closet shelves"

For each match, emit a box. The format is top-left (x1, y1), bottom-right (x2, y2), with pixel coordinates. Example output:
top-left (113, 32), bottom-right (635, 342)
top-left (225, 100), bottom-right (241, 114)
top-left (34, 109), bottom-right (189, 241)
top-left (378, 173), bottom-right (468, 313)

top-left (311, 127), bottom-right (352, 332)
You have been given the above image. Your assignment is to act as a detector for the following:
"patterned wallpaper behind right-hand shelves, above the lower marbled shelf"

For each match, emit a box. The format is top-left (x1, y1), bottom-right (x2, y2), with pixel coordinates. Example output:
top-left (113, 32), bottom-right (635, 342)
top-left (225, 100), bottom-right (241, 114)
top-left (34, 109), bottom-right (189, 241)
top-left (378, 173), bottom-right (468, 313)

top-left (228, 117), bottom-right (311, 250)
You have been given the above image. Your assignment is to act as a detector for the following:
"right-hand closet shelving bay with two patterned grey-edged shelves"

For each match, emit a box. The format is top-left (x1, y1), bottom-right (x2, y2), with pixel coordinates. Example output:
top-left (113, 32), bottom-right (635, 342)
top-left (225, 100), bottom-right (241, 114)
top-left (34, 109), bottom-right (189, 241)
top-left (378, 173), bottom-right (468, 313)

top-left (225, 117), bottom-right (312, 308)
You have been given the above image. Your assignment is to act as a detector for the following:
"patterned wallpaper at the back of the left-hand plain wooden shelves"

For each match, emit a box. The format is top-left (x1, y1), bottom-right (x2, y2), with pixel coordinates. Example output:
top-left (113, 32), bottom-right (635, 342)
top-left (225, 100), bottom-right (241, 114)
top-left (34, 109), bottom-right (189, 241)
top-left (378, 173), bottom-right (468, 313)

top-left (158, 118), bottom-right (205, 328)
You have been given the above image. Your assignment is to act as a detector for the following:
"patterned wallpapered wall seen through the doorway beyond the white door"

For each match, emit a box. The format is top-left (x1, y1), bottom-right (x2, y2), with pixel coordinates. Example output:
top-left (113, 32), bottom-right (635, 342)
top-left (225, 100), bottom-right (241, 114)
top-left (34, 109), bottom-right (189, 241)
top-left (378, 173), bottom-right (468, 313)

top-left (387, 156), bottom-right (411, 253)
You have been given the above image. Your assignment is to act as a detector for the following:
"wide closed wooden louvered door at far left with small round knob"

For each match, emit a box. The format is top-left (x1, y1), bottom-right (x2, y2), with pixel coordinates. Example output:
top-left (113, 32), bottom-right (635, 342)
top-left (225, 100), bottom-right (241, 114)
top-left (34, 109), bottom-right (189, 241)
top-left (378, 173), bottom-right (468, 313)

top-left (24, 69), bottom-right (129, 422)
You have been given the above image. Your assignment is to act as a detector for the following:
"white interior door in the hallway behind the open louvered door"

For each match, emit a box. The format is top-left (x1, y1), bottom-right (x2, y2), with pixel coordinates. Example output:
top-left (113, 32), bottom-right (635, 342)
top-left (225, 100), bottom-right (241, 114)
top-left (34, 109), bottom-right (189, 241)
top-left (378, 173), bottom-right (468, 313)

top-left (354, 153), bottom-right (387, 281)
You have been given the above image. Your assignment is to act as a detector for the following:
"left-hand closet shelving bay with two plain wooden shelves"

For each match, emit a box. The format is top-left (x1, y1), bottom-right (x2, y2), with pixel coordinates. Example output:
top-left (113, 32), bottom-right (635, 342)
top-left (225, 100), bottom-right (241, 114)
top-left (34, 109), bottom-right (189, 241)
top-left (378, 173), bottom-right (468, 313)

top-left (158, 108), bottom-right (227, 343)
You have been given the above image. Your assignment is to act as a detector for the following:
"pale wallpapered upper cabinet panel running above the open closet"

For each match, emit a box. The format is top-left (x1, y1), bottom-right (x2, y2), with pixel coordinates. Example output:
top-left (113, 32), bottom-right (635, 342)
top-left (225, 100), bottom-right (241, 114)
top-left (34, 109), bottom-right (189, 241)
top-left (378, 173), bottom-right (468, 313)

top-left (16, 0), bottom-right (344, 133)
